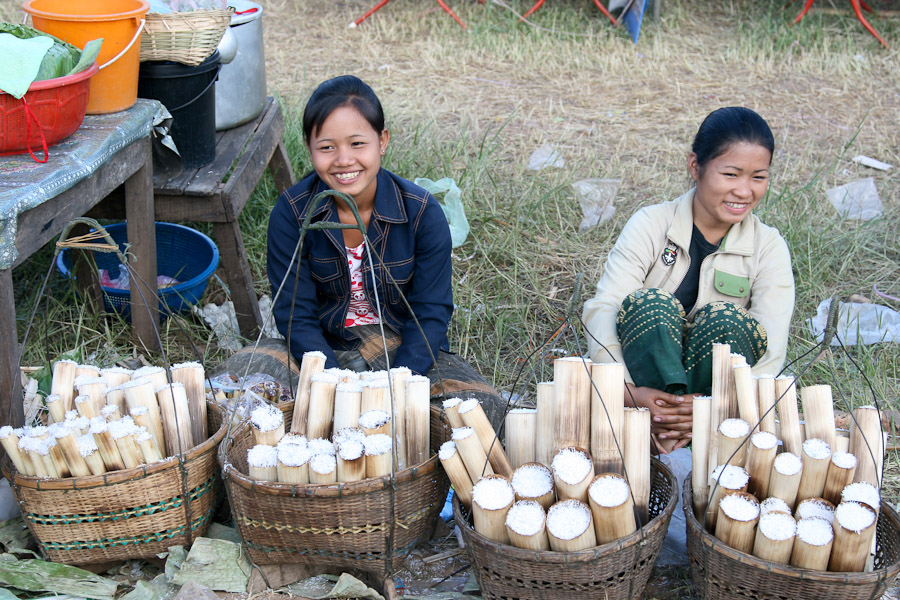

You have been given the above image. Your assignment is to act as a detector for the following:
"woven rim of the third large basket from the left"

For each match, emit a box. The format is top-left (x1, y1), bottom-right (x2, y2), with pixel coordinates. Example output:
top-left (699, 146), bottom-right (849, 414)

top-left (453, 457), bottom-right (678, 564)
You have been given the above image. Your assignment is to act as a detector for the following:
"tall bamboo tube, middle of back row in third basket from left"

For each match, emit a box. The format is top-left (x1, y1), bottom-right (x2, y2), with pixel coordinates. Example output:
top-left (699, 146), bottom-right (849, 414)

top-left (553, 356), bottom-right (591, 451)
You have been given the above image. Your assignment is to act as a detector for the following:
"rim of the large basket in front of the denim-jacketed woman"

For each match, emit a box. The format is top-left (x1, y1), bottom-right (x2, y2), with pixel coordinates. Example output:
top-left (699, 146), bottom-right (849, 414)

top-left (218, 402), bottom-right (450, 498)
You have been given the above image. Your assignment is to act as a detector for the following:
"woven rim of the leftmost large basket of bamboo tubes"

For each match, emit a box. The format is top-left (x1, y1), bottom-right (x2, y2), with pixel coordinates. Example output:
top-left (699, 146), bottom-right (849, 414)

top-left (3, 402), bottom-right (227, 491)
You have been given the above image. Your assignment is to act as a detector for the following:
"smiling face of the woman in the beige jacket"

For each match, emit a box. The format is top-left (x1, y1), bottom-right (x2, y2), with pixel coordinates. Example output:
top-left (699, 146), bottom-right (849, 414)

top-left (688, 142), bottom-right (772, 244)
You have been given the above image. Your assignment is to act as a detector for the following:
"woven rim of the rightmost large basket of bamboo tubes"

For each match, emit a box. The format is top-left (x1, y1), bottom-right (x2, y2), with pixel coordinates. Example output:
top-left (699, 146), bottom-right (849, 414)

top-left (682, 473), bottom-right (900, 585)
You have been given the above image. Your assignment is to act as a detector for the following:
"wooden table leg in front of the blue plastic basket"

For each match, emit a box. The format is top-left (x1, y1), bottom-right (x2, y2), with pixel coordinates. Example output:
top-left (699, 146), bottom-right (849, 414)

top-left (125, 138), bottom-right (160, 350)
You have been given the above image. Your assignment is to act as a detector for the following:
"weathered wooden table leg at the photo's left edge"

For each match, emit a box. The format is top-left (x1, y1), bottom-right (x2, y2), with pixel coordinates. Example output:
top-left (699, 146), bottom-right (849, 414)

top-left (0, 269), bottom-right (25, 427)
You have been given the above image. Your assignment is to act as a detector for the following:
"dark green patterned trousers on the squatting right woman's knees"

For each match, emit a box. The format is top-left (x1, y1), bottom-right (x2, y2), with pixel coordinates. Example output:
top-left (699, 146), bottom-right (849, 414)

top-left (616, 289), bottom-right (767, 394)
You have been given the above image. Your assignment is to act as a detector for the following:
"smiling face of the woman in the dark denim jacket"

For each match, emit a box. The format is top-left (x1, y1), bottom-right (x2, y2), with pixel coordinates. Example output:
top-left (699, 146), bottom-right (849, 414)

top-left (309, 106), bottom-right (390, 209)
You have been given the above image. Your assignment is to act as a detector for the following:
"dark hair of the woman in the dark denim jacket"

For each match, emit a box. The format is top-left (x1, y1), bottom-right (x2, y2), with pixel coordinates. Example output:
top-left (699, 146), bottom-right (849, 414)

top-left (303, 75), bottom-right (384, 143)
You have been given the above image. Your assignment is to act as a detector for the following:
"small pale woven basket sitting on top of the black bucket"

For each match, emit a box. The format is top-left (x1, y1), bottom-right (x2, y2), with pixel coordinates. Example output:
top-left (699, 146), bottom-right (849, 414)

top-left (141, 7), bottom-right (234, 67)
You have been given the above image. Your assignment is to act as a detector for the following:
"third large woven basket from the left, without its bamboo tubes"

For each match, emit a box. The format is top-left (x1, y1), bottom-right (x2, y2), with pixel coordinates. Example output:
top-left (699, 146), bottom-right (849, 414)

top-left (453, 458), bottom-right (678, 600)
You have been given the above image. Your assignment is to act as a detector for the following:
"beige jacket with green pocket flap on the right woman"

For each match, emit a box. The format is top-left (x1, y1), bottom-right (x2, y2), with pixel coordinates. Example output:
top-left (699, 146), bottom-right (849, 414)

top-left (584, 190), bottom-right (794, 384)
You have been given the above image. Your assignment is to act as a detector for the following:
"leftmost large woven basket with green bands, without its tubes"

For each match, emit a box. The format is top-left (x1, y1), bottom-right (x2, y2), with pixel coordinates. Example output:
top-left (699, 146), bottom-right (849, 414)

top-left (3, 404), bottom-right (225, 565)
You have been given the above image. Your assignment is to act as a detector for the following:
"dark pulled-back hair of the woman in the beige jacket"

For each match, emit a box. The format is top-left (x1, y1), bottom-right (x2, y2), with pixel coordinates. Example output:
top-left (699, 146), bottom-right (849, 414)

top-left (691, 106), bottom-right (775, 172)
